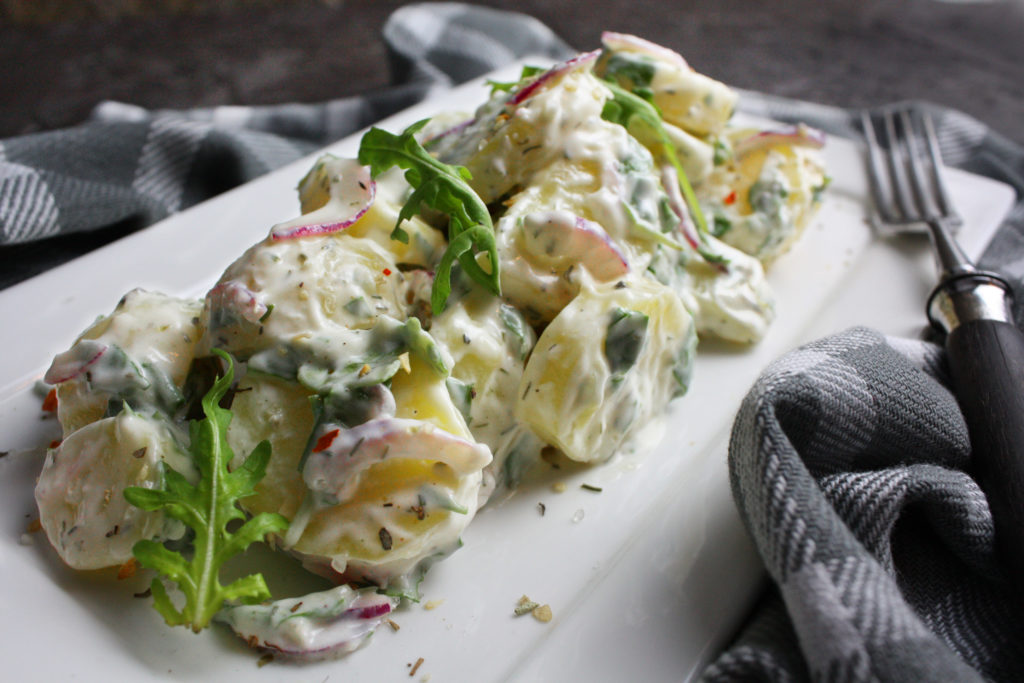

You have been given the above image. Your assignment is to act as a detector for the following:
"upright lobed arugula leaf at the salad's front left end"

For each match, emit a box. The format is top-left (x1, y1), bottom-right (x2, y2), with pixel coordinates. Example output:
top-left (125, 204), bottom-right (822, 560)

top-left (124, 349), bottom-right (288, 633)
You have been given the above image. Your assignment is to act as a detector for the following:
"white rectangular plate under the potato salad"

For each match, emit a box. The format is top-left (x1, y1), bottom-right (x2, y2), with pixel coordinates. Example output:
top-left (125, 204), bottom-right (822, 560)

top-left (0, 60), bottom-right (1013, 683)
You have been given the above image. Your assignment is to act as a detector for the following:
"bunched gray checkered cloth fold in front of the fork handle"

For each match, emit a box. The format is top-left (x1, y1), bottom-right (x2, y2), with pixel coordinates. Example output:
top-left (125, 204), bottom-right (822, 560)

top-left (703, 329), bottom-right (1024, 682)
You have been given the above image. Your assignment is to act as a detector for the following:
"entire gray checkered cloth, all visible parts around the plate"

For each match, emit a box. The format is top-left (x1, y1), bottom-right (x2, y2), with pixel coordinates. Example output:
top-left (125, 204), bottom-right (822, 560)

top-left (0, 4), bottom-right (1024, 683)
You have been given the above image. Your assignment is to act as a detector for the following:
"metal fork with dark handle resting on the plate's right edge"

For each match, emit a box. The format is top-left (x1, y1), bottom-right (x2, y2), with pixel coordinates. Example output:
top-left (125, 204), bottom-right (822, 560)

top-left (861, 105), bottom-right (1024, 588)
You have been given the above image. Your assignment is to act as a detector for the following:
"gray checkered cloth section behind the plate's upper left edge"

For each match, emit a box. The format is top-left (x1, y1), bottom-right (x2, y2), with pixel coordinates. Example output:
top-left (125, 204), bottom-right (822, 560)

top-left (0, 3), bottom-right (574, 288)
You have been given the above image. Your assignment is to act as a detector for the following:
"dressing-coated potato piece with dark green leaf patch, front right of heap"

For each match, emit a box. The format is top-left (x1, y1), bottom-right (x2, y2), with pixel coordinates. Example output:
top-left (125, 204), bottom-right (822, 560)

top-left (516, 278), bottom-right (696, 462)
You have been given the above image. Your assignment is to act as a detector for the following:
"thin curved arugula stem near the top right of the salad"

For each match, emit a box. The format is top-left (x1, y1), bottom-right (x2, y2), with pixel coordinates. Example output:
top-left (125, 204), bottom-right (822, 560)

top-left (601, 81), bottom-right (727, 263)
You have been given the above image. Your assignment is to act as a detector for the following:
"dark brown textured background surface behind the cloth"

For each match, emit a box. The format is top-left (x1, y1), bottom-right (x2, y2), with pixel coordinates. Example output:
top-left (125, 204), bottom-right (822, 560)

top-left (0, 0), bottom-right (1024, 143)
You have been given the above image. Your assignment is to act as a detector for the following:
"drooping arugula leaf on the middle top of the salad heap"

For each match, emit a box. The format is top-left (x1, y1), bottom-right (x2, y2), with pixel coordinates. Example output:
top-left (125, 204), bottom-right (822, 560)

top-left (358, 119), bottom-right (501, 315)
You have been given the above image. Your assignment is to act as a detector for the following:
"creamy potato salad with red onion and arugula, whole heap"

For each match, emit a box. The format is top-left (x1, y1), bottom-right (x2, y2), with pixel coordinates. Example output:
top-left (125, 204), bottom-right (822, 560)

top-left (35, 33), bottom-right (827, 656)
